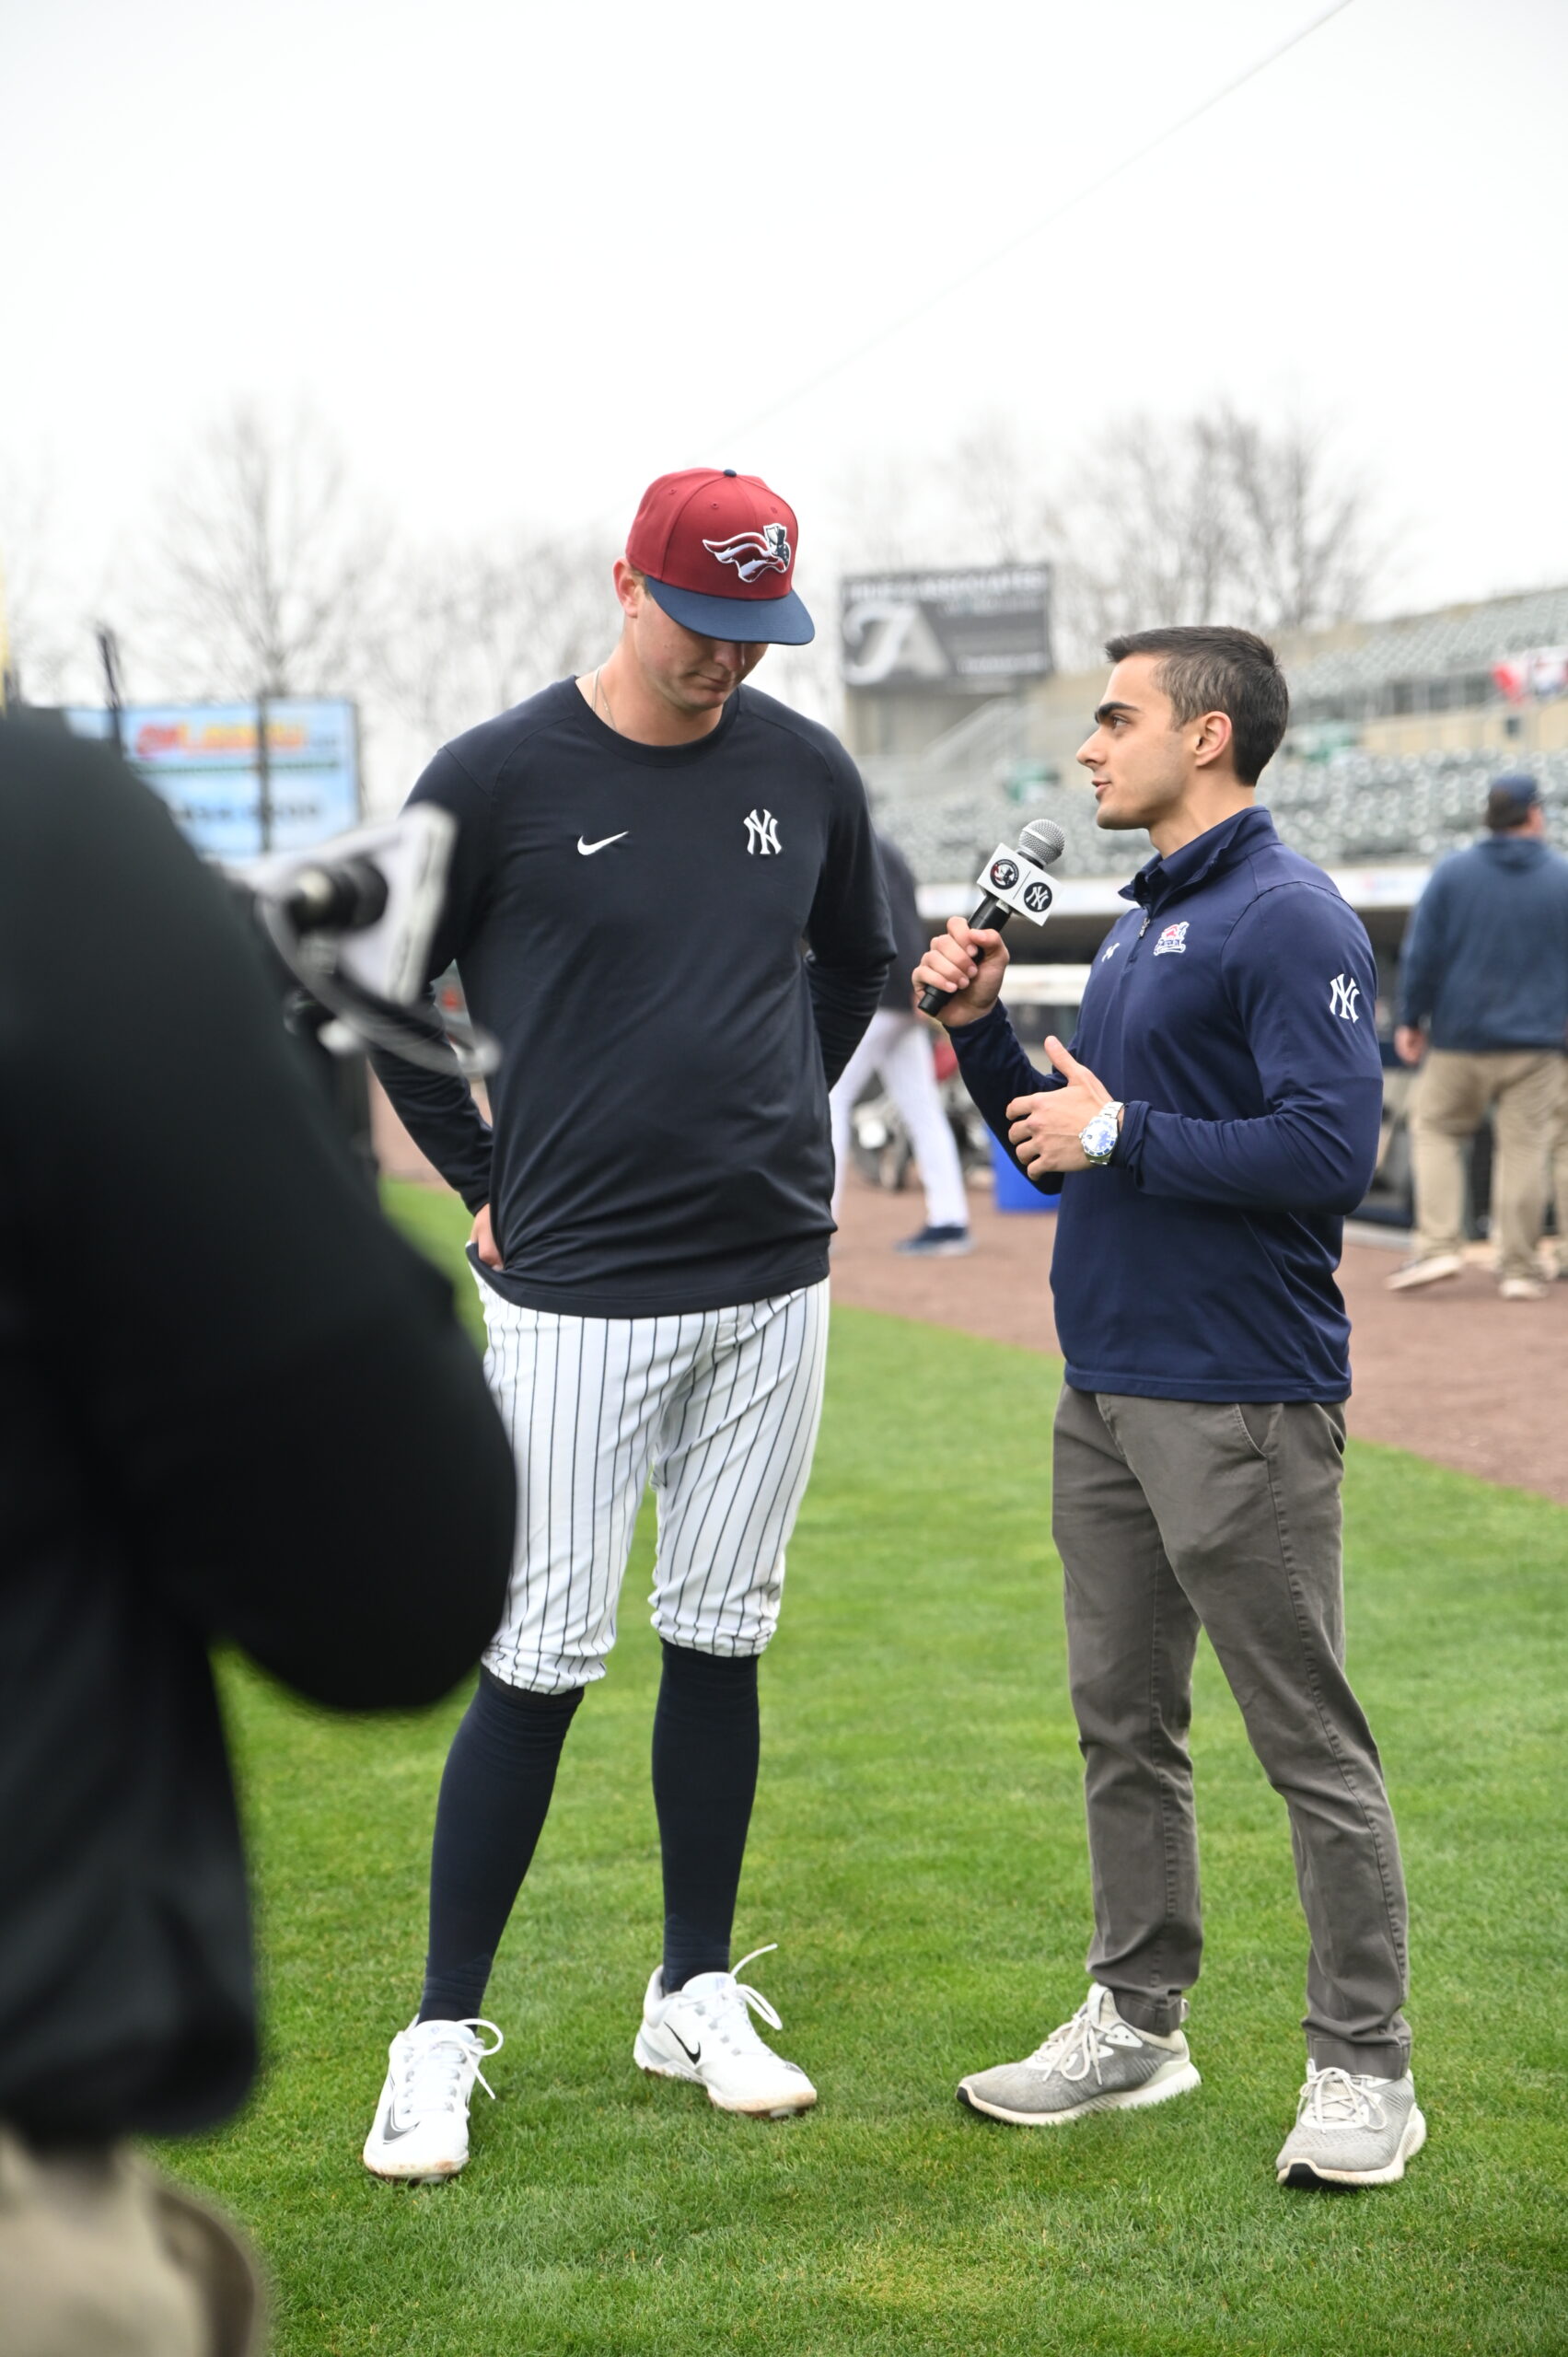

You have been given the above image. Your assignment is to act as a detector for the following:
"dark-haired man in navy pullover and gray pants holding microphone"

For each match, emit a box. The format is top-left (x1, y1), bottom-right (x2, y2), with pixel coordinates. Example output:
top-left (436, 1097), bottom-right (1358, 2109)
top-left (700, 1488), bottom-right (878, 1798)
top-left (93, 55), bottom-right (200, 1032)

top-left (915, 627), bottom-right (1426, 2185)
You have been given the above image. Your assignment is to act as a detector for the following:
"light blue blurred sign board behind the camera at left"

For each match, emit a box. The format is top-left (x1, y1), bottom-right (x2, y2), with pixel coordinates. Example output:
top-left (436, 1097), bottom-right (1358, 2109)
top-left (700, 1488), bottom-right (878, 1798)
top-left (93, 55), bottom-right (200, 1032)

top-left (66, 695), bottom-right (361, 860)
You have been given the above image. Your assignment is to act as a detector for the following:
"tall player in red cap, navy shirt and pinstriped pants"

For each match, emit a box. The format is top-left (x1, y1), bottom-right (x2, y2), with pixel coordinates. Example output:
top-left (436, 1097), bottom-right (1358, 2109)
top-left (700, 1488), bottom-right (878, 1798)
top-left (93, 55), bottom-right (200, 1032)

top-left (366, 469), bottom-right (891, 2177)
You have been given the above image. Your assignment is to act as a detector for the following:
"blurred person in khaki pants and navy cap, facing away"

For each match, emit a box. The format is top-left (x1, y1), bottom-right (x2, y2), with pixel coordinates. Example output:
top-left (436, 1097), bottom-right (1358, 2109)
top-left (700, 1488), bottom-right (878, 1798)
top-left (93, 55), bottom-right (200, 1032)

top-left (1388, 773), bottom-right (1568, 1301)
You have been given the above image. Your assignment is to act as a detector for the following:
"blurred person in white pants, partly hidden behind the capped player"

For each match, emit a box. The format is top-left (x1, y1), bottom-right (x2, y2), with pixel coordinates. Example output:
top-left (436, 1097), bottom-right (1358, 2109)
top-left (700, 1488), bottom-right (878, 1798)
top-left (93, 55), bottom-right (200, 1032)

top-left (832, 834), bottom-right (974, 1259)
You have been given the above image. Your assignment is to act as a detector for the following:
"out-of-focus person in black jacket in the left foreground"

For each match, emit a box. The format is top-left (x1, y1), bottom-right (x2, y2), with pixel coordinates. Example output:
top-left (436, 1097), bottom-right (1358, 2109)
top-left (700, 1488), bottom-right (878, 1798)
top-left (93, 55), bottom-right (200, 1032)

top-left (0, 724), bottom-right (514, 2357)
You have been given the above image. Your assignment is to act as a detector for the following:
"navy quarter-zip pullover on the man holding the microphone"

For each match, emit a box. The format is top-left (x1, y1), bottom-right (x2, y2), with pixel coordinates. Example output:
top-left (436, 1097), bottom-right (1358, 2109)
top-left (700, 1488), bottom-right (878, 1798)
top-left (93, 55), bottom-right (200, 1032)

top-left (953, 808), bottom-right (1382, 1400)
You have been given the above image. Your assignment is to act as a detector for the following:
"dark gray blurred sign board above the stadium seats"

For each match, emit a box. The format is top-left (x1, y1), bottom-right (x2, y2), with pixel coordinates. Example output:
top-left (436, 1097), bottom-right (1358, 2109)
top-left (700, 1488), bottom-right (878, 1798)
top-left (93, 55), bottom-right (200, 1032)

top-left (842, 565), bottom-right (1054, 695)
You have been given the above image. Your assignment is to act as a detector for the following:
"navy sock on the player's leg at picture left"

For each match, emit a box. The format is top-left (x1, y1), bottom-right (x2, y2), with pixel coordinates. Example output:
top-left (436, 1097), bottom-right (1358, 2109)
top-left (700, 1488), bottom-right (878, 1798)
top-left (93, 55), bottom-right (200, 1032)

top-left (420, 1668), bottom-right (583, 2022)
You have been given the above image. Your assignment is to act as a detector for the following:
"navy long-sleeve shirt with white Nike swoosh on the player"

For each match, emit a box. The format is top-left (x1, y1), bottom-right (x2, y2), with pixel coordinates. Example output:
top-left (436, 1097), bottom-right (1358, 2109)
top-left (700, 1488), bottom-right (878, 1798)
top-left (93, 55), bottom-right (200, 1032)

top-left (377, 679), bottom-right (894, 1318)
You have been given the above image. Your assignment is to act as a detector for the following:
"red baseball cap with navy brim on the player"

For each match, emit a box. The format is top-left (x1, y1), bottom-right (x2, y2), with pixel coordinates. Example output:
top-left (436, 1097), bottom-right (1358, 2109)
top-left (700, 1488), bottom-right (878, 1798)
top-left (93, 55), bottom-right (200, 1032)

top-left (627, 467), bottom-right (816, 645)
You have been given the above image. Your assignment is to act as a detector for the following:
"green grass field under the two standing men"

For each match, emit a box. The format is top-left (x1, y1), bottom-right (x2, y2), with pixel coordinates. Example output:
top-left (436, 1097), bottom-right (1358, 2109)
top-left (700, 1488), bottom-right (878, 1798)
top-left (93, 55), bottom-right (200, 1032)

top-left (175, 1192), bottom-right (1568, 2357)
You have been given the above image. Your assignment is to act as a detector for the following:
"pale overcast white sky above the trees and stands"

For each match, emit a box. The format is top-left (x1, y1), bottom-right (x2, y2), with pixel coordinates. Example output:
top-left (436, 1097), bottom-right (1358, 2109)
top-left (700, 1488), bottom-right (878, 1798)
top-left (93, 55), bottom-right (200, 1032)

top-left (0, 0), bottom-right (1568, 697)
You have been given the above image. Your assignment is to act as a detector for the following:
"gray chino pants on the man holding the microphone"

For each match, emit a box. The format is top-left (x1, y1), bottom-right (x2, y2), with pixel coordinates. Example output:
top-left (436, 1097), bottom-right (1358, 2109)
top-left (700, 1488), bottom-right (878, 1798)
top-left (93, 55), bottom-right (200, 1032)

top-left (1051, 1386), bottom-right (1410, 2076)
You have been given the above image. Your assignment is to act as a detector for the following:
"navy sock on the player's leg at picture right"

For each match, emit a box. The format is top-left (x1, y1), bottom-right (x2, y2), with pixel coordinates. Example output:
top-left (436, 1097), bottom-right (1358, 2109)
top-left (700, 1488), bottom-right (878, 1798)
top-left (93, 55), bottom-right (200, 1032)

top-left (653, 1643), bottom-right (760, 1994)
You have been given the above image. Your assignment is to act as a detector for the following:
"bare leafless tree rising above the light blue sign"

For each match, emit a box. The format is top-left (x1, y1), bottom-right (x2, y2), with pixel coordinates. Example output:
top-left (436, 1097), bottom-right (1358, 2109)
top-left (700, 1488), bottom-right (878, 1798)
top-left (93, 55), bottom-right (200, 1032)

top-left (142, 403), bottom-right (387, 698)
